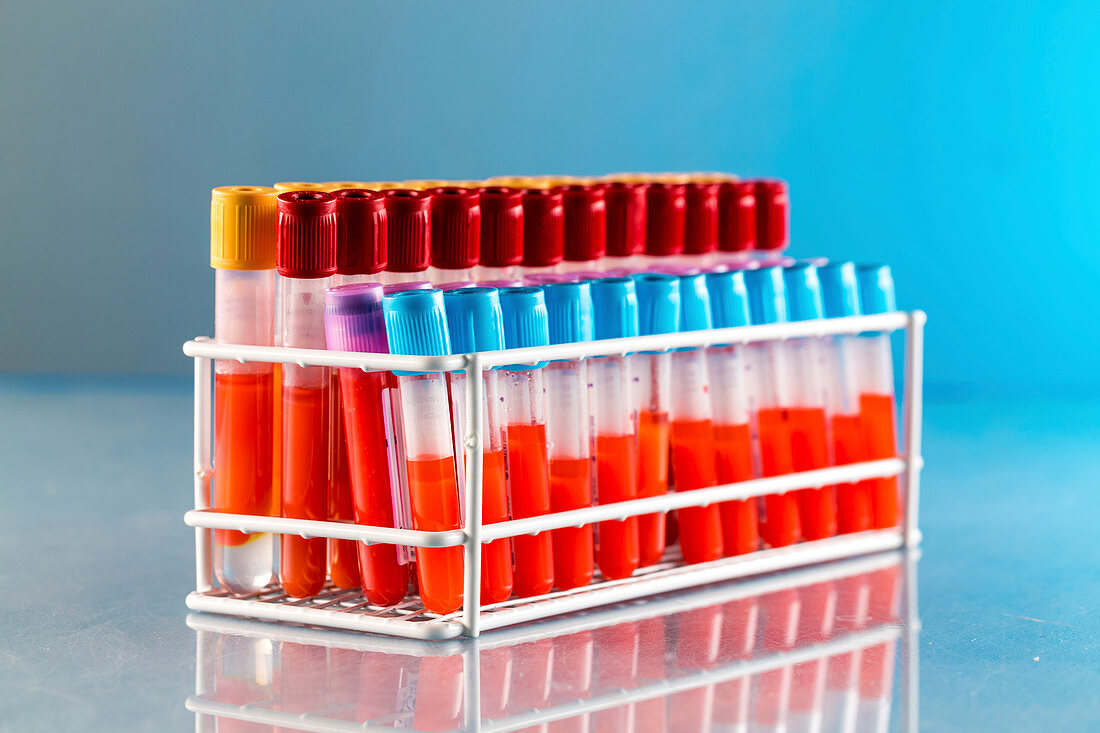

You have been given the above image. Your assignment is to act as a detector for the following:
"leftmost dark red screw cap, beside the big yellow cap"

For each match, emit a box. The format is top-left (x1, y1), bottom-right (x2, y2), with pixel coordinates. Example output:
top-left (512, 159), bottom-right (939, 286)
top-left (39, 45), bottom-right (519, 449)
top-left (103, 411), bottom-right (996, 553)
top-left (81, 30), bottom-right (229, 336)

top-left (275, 190), bottom-right (337, 278)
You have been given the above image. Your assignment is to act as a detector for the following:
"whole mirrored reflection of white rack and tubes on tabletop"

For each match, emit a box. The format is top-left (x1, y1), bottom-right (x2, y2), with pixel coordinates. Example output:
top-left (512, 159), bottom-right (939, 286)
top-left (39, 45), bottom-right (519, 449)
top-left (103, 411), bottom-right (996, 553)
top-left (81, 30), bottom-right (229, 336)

top-left (186, 550), bottom-right (920, 733)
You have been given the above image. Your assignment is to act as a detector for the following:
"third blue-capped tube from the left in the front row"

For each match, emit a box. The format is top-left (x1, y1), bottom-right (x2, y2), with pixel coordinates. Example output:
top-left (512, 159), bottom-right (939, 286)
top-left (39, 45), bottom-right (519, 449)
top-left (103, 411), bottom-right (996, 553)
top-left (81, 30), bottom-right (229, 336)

top-left (501, 287), bottom-right (554, 598)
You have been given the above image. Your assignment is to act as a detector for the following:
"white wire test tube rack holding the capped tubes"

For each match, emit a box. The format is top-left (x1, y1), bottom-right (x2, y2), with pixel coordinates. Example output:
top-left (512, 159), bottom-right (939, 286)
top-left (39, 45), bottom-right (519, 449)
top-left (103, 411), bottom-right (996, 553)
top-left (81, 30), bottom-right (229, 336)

top-left (184, 310), bottom-right (925, 639)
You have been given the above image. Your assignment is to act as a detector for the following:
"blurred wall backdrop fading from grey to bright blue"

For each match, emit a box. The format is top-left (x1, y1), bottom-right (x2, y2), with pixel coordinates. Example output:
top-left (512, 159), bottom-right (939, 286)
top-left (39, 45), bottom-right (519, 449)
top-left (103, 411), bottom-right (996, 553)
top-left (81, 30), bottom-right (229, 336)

top-left (0, 0), bottom-right (1100, 396)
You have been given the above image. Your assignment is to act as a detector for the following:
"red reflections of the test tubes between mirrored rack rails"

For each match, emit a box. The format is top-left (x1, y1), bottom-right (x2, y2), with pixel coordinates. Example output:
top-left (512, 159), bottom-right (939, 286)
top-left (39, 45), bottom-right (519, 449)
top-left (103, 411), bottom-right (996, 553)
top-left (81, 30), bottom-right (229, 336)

top-left (198, 556), bottom-right (913, 733)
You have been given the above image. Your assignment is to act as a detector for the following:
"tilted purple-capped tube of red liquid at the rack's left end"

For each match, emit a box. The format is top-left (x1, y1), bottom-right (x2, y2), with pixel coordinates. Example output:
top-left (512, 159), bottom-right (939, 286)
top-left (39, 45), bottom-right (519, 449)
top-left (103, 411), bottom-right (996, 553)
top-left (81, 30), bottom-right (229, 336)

top-left (325, 283), bottom-right (409, 605)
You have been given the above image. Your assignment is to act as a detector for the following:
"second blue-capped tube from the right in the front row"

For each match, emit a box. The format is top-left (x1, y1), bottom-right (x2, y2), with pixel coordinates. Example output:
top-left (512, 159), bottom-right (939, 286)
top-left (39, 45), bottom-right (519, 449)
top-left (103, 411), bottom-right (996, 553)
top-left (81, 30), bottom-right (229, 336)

top-left (817, 262), bottom-right (873, 534)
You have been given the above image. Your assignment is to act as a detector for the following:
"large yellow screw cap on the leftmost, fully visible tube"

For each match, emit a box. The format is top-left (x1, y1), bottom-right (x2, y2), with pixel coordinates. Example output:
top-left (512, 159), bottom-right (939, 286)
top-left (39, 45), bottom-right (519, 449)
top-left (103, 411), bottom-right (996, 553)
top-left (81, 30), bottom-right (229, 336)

top-left (210, 186), bottom-right (277, 270)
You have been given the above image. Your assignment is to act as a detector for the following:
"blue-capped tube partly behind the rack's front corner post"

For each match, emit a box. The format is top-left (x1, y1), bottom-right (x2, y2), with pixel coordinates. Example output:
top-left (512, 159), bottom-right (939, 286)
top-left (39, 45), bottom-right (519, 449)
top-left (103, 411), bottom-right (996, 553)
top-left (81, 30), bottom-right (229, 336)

top-left (443, 287), bottom-right (513, 603)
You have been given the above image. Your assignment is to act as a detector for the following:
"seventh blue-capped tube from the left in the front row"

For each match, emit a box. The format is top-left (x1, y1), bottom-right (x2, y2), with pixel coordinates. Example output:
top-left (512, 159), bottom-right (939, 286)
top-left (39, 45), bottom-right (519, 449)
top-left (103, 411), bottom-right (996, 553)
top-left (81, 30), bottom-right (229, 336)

top-left (671, 274), bottom-right (724, 562)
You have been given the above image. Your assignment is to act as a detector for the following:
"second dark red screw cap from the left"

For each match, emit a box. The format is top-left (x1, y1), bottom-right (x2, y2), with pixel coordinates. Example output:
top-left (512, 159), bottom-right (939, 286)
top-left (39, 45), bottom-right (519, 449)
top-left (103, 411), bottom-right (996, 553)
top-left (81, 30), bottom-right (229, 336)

top-left (332, 188), bottom-right (386, 275)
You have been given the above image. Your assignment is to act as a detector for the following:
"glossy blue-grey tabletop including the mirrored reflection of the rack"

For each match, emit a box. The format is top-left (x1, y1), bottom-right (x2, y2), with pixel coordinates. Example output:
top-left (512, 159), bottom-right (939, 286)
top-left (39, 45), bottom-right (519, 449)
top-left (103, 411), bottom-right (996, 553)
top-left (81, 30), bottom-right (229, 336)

top-left (0, 376), bottom-right (1100, 731)
